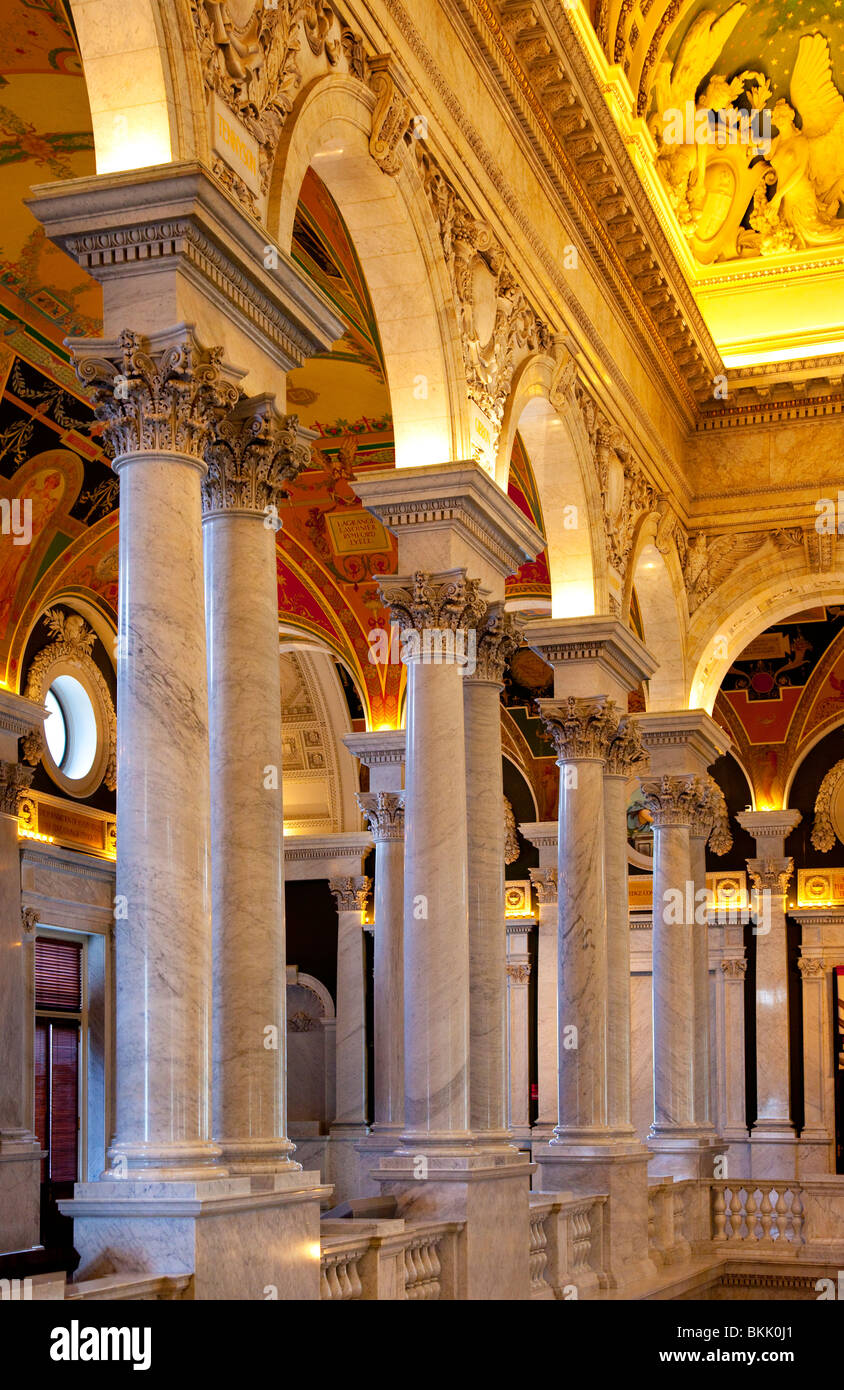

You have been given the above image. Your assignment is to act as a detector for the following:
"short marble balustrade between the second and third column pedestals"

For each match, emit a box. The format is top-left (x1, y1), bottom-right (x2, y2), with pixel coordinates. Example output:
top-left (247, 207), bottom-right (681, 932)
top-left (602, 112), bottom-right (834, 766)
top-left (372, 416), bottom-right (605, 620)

top-left (528, 1193), bottom-right (606, 1300)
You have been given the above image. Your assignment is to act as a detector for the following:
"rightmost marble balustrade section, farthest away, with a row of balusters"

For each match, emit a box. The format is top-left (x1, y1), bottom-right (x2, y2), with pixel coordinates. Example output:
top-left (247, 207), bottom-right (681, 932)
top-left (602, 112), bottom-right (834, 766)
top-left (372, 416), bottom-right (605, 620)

top-left (712, 1179), bottom-right (805, 1251)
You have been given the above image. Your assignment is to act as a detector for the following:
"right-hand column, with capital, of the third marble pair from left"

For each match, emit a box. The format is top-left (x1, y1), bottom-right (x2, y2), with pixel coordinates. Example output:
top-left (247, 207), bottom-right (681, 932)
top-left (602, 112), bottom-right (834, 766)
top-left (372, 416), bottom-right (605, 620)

top-left (603, 714), bottom-right (648, 1141)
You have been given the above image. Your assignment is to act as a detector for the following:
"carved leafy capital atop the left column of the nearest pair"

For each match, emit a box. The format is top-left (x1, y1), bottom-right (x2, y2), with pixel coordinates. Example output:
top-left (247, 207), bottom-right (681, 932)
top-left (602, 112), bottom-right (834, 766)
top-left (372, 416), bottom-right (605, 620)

top-left (75, 329), bottom-right (238, 460)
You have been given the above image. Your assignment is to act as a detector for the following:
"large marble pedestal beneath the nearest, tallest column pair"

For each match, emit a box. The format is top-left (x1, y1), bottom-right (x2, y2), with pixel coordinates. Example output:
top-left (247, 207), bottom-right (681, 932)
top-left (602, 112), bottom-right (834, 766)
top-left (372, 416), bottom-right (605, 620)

top-left (58, 1172), bottom-right (330, 1301)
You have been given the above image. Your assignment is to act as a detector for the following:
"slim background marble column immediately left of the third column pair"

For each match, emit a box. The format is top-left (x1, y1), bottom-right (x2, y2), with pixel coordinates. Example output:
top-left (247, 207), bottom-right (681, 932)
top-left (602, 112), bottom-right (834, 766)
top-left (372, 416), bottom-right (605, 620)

top-left (519, 820), bottom-right (558, 1140)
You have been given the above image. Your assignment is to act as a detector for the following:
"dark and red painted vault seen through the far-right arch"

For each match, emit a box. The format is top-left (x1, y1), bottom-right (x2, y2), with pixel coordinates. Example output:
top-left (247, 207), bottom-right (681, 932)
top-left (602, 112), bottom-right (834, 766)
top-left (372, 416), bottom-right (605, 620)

top-left (713, 605), bottom-right (844, 809)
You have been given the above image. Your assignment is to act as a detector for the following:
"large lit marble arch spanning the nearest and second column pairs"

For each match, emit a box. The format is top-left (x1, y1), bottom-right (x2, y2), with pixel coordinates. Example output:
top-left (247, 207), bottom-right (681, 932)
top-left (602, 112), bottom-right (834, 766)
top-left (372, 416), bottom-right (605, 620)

top-left (267, 72), bottom-right (469, 467)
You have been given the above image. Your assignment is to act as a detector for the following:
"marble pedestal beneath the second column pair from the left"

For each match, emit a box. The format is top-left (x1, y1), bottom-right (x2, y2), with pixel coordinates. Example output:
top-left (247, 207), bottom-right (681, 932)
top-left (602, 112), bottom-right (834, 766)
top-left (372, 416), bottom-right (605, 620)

top-left (373, 1144), bottom-right (534, 1302)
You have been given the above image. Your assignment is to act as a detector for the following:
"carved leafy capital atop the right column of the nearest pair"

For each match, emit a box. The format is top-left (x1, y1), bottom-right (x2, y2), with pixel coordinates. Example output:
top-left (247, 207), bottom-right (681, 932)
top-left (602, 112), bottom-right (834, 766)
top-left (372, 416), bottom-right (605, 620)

top-left (202, 395), bottom-right (310, 516)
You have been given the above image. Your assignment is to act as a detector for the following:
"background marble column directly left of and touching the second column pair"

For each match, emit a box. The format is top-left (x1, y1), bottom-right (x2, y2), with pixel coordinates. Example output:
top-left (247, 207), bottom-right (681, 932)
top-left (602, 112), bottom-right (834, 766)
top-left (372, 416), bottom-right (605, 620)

top-left (357, 791), bottom-right (405, 1136)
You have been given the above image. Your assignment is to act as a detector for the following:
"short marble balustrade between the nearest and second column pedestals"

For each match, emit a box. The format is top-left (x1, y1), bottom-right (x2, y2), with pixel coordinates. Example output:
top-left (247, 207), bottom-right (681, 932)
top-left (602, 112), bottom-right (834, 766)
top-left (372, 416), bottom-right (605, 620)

top-left (320, 1220), bottom-right (463, 1302)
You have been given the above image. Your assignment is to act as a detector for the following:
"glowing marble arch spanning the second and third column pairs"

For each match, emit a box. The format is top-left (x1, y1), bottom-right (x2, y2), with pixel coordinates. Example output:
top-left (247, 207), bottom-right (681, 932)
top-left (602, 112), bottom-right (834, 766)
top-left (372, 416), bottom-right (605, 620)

top-left (495, 354), bottom-right (608, 617)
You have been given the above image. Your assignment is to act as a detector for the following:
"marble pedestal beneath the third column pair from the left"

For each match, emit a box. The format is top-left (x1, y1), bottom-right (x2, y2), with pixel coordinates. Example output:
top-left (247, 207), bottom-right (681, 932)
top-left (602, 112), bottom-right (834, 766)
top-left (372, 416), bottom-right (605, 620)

top-left (533, 1141), bottom-right (656, 1289)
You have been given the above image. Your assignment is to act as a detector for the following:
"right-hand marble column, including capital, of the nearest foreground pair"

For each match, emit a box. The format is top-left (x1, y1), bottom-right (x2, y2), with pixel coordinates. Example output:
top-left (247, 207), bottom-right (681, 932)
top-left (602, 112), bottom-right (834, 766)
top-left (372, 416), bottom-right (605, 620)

top-left (202, 396), bottom-right (310, 1172)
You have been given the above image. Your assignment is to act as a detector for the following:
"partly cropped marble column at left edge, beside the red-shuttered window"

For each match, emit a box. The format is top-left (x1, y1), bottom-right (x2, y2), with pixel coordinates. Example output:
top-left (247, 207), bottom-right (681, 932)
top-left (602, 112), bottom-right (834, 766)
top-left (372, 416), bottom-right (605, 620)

top-left (0, 689), bottom-right (46, 1254)
